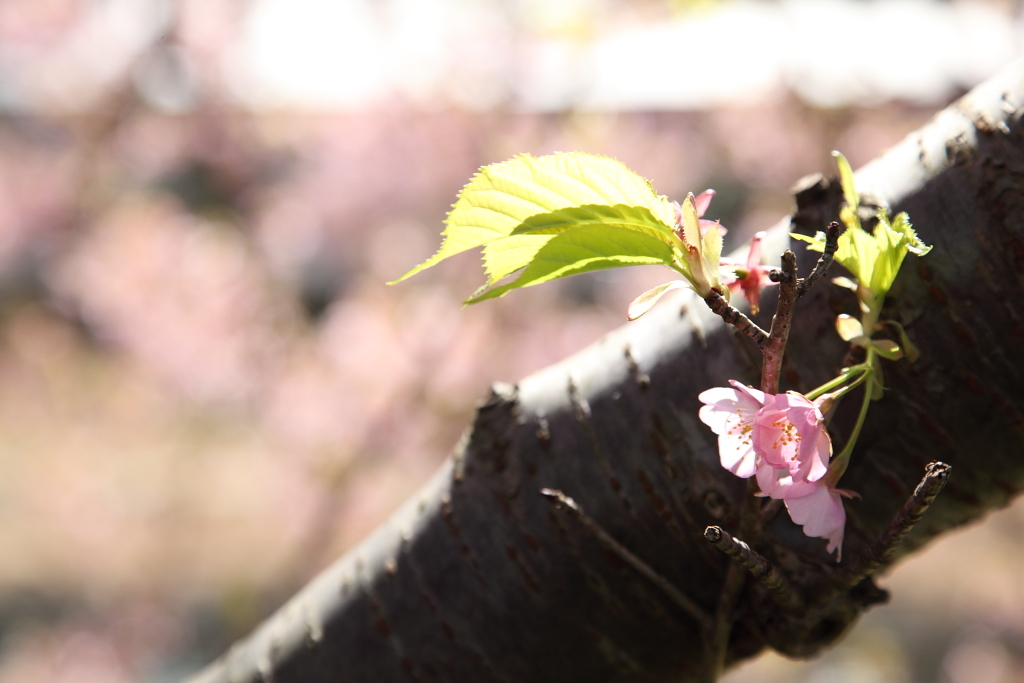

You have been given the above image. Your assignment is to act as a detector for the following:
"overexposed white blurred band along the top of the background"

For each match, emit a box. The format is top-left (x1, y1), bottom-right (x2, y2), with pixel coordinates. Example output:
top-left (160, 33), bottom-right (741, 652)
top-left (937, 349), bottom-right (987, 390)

top-left (0, 0), bottom-right (1024, 112)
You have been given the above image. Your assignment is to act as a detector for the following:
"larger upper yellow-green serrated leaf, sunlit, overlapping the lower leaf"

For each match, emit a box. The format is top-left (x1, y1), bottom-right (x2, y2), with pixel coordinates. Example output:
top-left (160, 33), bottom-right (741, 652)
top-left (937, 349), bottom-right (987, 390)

top-left (390, 153), bottom-right (678, 285)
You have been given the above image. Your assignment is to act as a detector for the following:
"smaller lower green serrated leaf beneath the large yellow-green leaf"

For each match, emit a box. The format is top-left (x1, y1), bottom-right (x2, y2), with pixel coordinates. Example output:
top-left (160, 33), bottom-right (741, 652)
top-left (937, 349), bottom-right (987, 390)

top-left (465, 225), bottom-right (676, 304)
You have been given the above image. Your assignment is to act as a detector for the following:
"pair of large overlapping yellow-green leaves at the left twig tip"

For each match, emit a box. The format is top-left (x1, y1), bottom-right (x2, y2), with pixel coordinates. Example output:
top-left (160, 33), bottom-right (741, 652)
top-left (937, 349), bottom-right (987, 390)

top-left (389, 153), bottom-right (689, 304)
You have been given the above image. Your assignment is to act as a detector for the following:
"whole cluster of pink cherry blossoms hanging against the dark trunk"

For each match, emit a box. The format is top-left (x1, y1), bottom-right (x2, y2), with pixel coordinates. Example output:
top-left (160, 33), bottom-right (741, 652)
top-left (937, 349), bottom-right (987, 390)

top-left (698, 380), bottom-right (856, 561)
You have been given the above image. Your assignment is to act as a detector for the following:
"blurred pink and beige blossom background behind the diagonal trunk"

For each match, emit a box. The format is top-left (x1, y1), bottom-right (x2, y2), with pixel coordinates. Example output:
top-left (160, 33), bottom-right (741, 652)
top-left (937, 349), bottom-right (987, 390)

top-left (0, 0), bottom-right (1024, 683)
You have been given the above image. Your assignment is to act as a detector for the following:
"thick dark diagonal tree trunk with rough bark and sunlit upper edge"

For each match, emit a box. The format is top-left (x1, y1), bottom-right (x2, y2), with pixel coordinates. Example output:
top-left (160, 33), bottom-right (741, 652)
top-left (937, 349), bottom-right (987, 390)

top-left (194, 63), bottom-right (1024, 683)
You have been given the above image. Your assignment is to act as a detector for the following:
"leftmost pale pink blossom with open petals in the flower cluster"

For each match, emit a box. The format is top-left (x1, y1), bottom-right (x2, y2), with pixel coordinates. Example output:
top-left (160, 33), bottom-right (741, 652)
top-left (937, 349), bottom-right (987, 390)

top-left (697, 380), bottom-right (774, 479)
